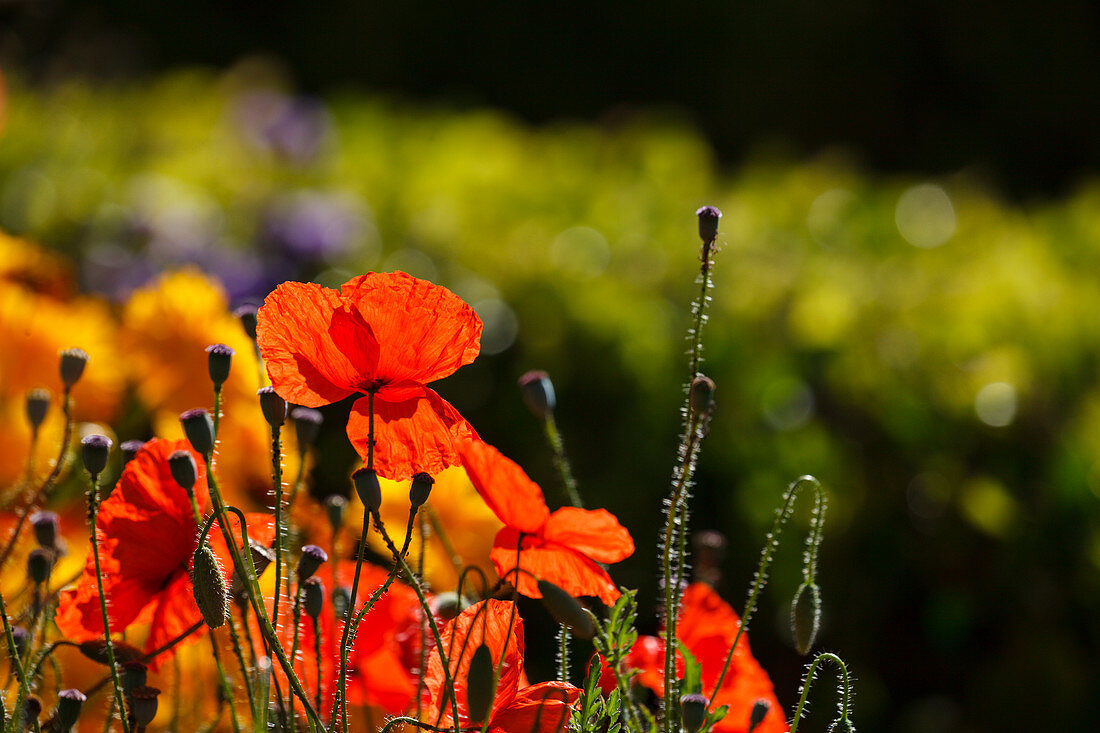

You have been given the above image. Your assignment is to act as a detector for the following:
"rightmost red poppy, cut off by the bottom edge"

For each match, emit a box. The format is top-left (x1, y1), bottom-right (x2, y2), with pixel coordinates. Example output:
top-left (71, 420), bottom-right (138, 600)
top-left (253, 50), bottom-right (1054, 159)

top-left (600, 583), bottom-right (787, 733)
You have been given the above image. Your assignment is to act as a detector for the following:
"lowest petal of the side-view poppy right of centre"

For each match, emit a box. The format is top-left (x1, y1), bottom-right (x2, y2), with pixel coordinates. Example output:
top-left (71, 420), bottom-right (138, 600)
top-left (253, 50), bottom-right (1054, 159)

top-left (490, 527), bottom-right (619, 604)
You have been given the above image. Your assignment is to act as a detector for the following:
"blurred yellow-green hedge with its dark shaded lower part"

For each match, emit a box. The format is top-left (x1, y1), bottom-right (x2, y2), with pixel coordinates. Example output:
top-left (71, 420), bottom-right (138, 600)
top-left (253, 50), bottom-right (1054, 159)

top-left (0, 68), bottom-right (1100, 731)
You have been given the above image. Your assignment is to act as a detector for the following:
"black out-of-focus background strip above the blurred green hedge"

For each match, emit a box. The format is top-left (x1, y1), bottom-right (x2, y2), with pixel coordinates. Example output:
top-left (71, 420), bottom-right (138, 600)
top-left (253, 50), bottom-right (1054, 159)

top-left (0, 0), bottom-right (1100, 194)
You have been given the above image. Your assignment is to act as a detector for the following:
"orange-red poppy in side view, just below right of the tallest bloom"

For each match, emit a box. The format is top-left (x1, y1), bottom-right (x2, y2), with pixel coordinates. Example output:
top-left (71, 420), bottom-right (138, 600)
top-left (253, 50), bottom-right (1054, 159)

top-left (460, 440), bottom-right (634, 603)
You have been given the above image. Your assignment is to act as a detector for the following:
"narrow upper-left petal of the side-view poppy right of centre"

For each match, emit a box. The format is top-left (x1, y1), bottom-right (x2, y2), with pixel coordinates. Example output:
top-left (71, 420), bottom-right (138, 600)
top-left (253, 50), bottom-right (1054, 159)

top-left (459, 433), bottom-right (550, 534)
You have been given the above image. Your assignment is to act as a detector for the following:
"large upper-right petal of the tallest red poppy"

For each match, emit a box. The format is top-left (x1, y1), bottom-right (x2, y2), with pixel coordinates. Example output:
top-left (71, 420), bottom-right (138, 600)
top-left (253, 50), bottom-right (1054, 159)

top-left (340, 272), bottom-right (482, 384)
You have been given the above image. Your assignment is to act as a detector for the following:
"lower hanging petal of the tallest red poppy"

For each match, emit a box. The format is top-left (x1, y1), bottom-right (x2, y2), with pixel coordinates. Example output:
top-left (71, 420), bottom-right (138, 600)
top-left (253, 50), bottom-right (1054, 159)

top-left (348, 385), bottom-right (477, 481)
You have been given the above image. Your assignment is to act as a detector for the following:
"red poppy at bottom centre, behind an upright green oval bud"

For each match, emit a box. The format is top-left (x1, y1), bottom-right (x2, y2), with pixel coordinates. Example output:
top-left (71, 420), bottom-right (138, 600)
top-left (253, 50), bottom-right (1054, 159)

top-left (424, 599), bottom-right (581, 733)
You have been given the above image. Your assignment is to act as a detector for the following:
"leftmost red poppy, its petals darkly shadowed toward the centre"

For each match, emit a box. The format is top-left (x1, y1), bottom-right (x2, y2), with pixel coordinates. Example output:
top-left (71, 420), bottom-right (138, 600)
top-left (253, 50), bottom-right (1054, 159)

top-left (55, 438), bottom-right (274, 659)
